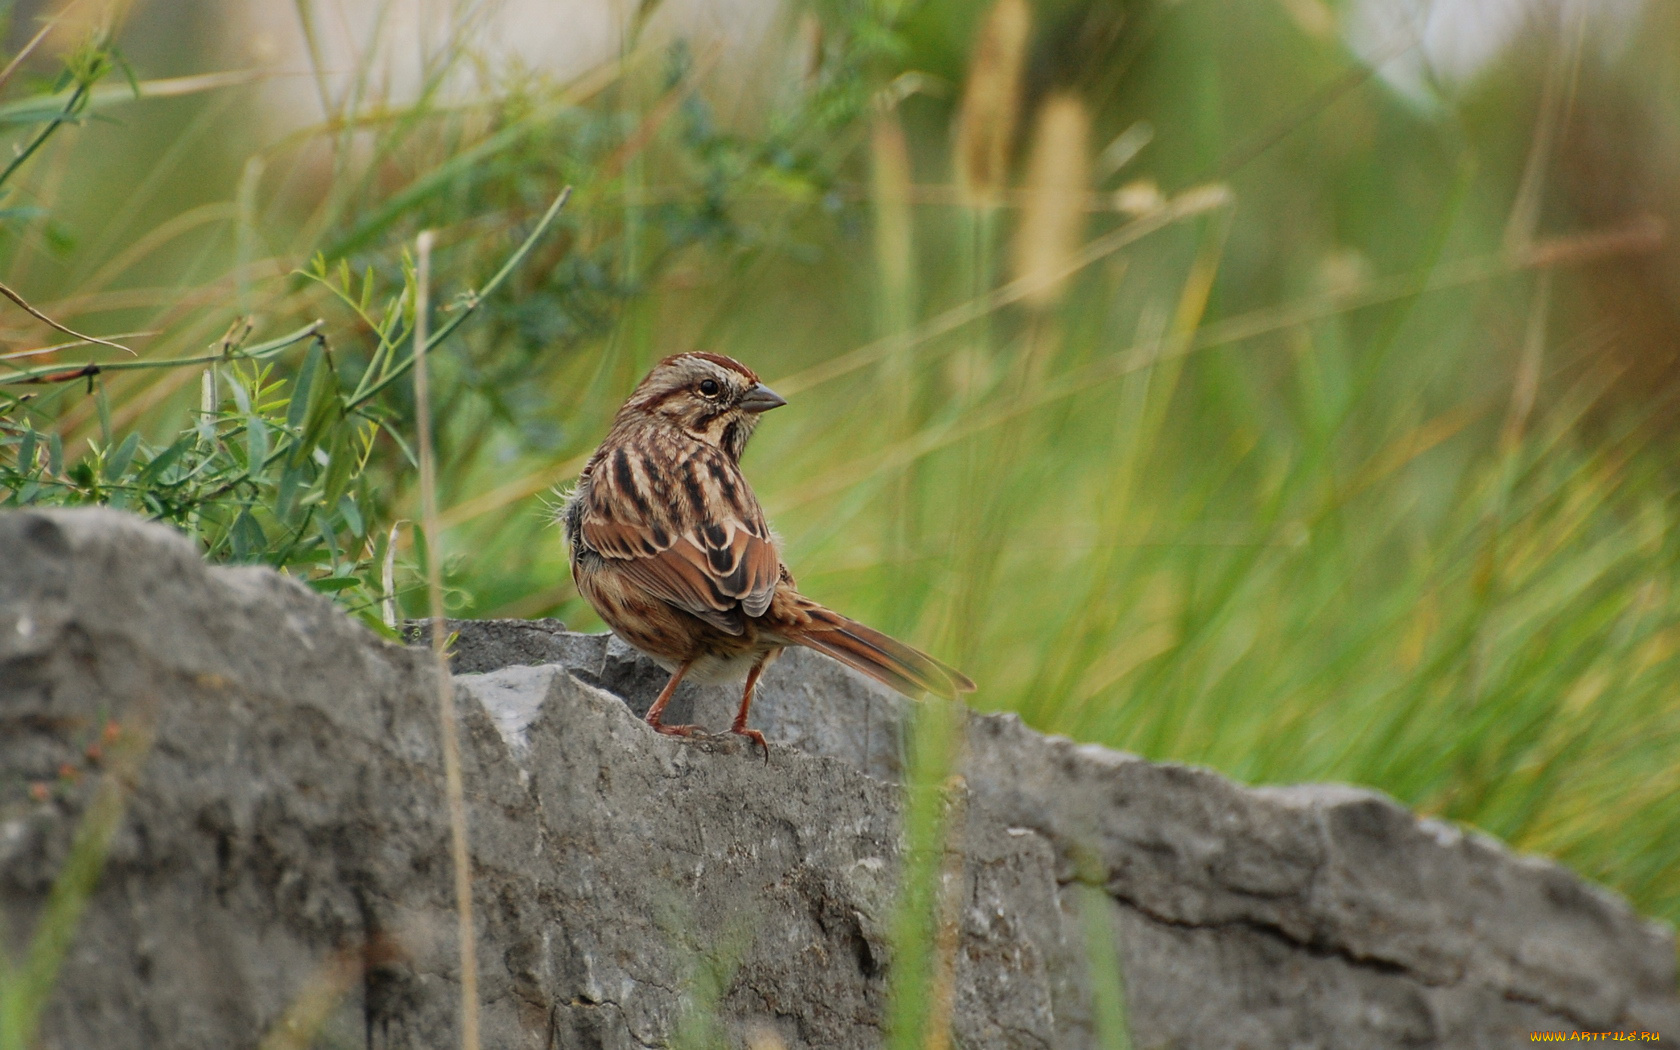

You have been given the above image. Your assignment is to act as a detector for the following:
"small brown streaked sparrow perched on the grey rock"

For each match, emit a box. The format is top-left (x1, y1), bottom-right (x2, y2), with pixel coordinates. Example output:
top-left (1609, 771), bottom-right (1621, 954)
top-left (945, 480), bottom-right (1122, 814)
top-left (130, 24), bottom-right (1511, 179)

top-left (558, 351), bottom-right (974, 761)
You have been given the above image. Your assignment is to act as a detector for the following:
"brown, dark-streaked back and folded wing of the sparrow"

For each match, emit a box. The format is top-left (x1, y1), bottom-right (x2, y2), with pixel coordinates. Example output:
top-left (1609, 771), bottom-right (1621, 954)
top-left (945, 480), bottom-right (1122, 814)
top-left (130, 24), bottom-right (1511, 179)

top-left (581, 445), bottom-right (781, 635)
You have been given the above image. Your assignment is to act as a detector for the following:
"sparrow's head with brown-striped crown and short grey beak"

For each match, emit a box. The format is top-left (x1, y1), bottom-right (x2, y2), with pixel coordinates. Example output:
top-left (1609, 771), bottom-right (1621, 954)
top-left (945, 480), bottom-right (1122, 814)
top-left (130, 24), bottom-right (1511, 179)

top-left (618, 351), bottom-right (788, 459)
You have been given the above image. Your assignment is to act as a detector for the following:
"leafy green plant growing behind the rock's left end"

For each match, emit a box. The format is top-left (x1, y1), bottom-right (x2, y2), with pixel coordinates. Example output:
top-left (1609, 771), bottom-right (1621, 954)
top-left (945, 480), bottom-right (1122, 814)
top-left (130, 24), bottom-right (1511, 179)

top-left (0, 315), bottom-right (396, 612)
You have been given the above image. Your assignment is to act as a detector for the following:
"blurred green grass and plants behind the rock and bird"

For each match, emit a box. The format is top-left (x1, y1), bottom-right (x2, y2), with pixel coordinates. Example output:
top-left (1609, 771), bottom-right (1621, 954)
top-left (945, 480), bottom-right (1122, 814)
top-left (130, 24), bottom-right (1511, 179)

top-left (0, 0), bottom-right (1680, 919)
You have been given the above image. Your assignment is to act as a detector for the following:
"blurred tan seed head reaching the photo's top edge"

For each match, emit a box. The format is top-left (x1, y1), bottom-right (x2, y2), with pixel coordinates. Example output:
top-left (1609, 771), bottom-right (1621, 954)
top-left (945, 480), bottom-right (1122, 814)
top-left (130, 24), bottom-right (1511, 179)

top-left (954, 0), bottom-right (1032, 208)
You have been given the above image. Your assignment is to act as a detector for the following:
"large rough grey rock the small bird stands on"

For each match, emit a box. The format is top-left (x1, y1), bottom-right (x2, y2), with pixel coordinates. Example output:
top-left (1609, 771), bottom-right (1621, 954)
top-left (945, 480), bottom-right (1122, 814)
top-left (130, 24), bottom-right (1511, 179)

top-left (0, 511), bottom-right (1680, 1050)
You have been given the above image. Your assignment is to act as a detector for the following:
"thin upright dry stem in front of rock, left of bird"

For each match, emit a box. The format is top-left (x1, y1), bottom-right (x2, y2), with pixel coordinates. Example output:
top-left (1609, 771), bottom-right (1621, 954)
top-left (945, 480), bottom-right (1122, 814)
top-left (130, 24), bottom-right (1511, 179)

top-left (413, 230), bottom-right (479, 1050)
